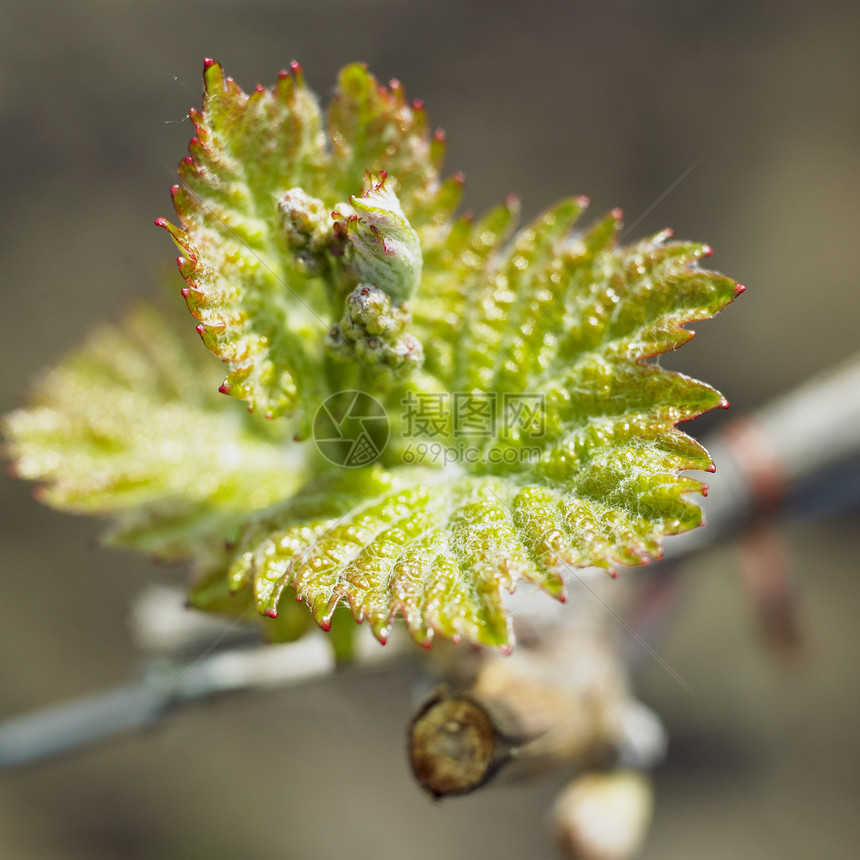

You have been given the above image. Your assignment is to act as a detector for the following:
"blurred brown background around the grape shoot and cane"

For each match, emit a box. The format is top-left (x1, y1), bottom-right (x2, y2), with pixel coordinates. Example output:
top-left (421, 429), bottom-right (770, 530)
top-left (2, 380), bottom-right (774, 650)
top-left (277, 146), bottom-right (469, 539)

top-left (0, 0), bottom-right (860, 860)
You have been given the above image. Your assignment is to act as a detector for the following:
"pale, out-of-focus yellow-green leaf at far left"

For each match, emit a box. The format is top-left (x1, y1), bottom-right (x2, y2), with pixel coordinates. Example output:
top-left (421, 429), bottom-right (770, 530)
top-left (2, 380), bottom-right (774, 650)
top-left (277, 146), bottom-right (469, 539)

top-left (3, 307), bottom-right (301, 560)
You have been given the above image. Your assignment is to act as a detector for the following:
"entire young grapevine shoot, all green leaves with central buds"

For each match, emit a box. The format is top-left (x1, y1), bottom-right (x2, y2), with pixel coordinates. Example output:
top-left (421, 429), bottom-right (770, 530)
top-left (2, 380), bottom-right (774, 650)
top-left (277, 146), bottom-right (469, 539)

top-left (5, 60), bottom-right (742, 648)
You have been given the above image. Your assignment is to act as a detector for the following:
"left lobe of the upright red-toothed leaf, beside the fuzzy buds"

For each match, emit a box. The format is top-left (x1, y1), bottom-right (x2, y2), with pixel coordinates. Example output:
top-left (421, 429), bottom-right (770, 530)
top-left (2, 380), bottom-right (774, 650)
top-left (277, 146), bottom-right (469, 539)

top-left (157, 61), bottom-right (328, 420)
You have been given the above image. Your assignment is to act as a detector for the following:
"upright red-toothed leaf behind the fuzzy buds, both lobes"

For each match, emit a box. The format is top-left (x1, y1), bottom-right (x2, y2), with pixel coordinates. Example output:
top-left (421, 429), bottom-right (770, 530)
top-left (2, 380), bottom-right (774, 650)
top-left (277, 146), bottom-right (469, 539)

top-left (157, 61), bottom-right (462, 424)
